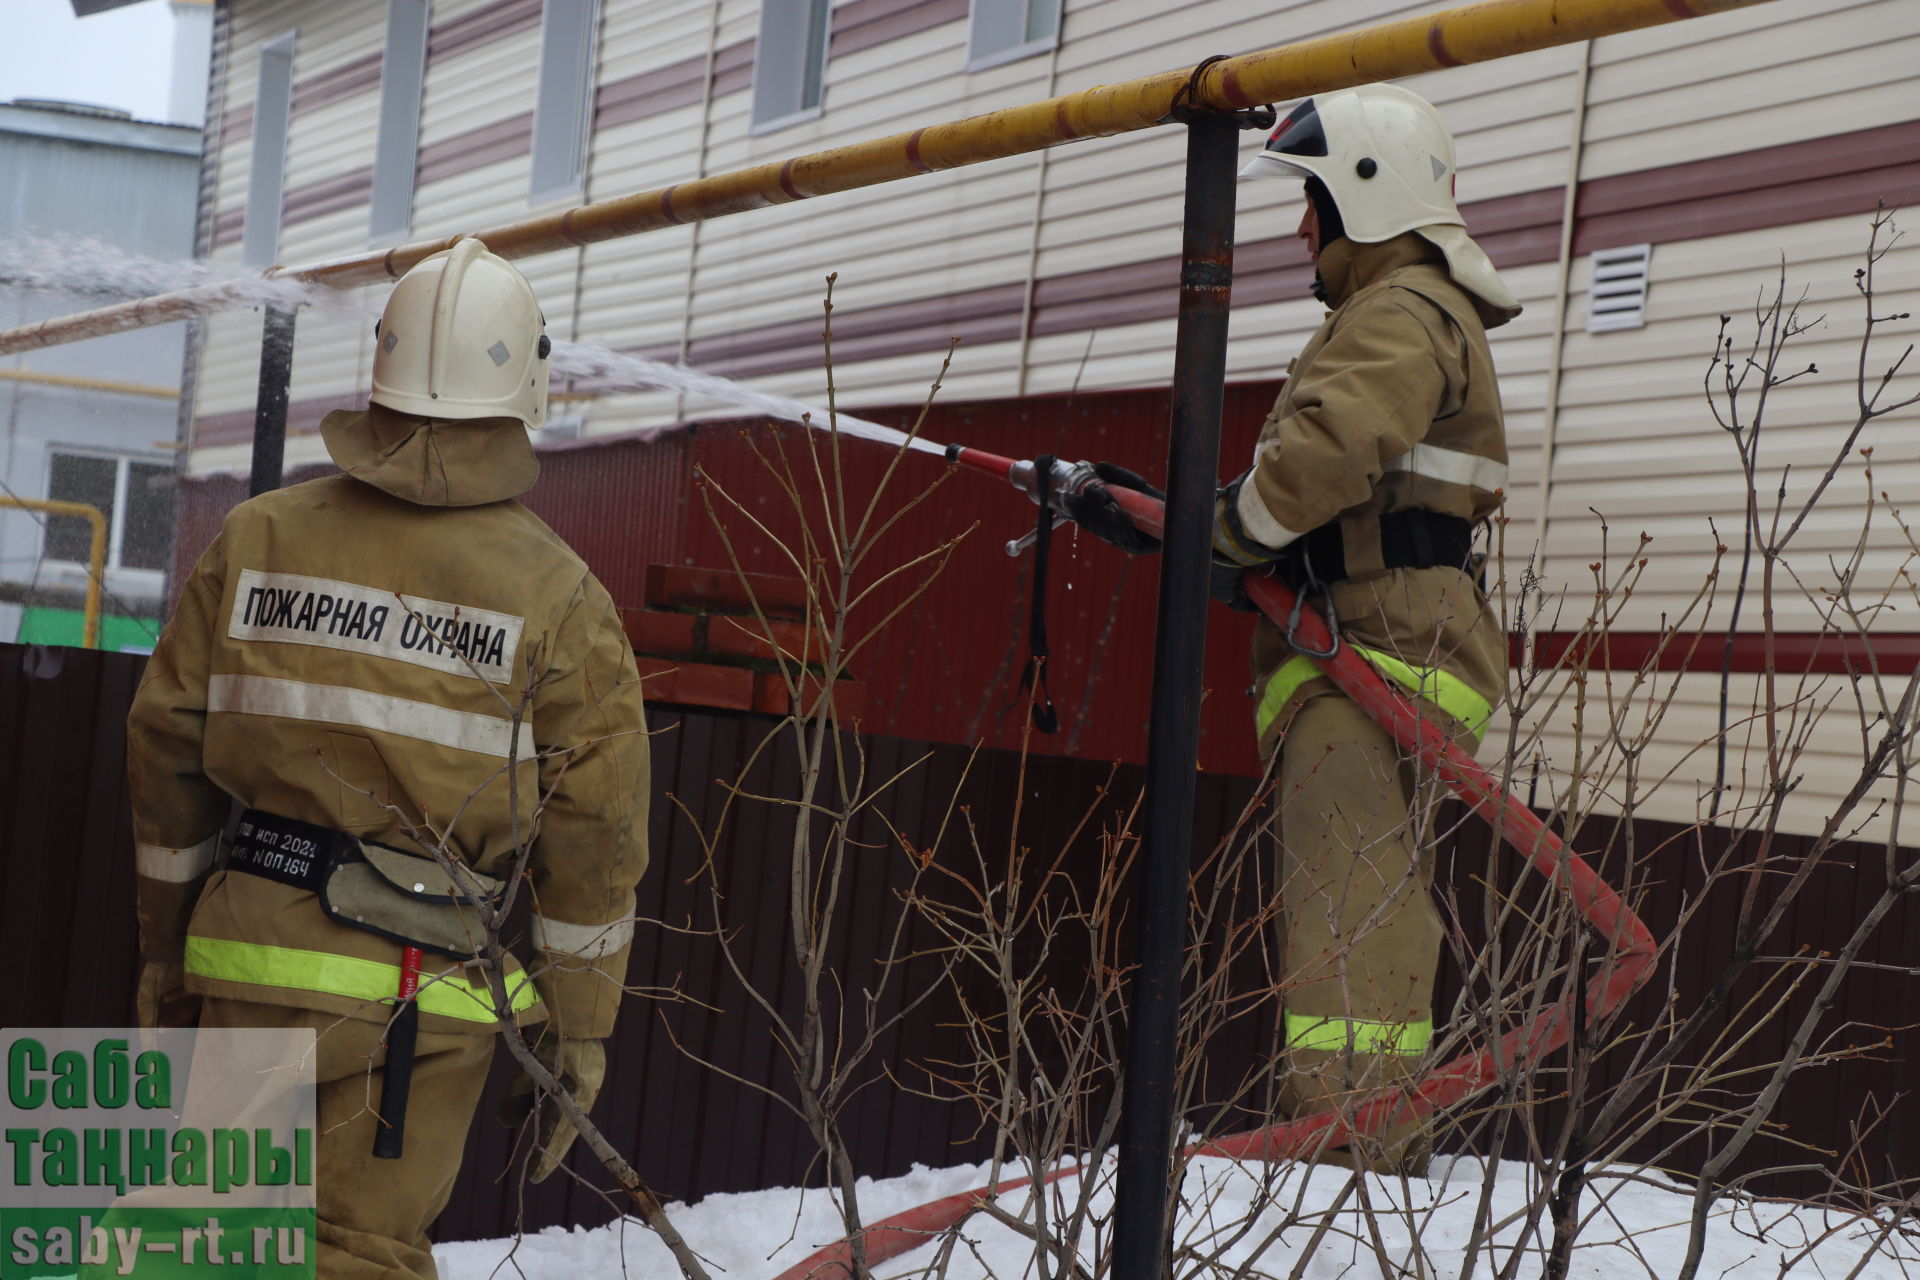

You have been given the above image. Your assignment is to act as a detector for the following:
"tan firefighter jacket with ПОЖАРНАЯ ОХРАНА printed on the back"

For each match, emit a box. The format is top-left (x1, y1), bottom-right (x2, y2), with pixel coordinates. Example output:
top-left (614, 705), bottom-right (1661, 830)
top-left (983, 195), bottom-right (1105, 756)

top-left (127, 407), bottom-right (647, 1038)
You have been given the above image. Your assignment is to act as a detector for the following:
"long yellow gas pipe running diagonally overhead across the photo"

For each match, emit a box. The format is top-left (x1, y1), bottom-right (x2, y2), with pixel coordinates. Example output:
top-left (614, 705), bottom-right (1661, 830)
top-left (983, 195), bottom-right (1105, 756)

top-left (0, 0), bottom-right (1766, 355)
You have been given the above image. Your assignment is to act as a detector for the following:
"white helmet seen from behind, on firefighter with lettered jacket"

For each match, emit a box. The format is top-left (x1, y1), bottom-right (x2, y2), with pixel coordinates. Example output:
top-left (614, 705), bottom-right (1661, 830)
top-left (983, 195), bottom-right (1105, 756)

top-left (372, 236), bottom-right (551, 428)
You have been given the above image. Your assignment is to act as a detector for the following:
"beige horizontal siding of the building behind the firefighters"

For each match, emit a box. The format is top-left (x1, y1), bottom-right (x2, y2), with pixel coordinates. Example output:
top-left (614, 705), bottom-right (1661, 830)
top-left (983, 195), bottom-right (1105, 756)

top-left (183, 0), bottom-right (1920, 829)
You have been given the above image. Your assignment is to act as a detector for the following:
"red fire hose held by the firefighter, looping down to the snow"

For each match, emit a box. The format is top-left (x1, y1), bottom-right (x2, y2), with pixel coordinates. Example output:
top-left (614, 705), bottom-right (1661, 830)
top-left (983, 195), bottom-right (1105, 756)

top-left (778, 445), bottom-right (1655, 1280)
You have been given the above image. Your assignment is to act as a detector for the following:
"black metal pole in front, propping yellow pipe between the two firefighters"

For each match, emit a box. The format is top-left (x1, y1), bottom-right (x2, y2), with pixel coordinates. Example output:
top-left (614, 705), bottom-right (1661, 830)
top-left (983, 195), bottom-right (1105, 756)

top-left (1114, 115), bottom-right (1240, 1280)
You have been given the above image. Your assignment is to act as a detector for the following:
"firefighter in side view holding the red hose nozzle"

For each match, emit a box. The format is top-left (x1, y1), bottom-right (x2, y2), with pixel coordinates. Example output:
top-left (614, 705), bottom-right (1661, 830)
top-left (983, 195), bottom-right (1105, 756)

top-left (1069, 84), bottom-right (1521, 1173)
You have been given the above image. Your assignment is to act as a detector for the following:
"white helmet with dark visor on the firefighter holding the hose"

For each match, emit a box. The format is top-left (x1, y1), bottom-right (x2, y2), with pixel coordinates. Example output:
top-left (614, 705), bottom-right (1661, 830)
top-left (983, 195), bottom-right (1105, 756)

top-left (1240, 84), bottom-right (1521, 315)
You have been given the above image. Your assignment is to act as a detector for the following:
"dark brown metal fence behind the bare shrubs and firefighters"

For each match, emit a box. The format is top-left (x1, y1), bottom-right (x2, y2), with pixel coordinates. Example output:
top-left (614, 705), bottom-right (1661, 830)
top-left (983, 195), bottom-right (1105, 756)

top-left (0, 645), bottom-right (1920, 1240)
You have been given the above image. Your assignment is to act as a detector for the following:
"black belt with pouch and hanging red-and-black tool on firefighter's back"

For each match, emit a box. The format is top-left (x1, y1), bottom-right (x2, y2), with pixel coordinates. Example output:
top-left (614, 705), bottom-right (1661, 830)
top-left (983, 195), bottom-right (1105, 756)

top-left (227, 810), bottom-right (507, 1159)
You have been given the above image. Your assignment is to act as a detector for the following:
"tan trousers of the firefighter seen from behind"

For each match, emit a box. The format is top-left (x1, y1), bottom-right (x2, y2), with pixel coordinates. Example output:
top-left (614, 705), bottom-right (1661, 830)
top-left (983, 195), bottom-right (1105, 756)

top-left (200, 996), bottom-right (495, 1280)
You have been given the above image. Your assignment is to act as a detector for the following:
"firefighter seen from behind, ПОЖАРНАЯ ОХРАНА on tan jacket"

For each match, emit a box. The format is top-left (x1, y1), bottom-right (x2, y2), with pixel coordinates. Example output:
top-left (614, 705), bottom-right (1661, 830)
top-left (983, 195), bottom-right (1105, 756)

top-left (129, 240), bottom-right (647, 1280)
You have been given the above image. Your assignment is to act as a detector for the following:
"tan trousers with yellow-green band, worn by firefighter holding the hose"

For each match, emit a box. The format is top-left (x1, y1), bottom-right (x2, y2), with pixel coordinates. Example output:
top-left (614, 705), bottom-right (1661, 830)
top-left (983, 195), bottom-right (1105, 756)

top-left (1275, 693), bottom-right (1442, 1173)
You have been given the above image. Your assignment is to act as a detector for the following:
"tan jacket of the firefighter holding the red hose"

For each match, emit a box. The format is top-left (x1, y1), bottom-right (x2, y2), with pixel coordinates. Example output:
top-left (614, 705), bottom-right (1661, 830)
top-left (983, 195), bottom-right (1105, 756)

top-left (1236, 232), bottom-right (1511, 752)
